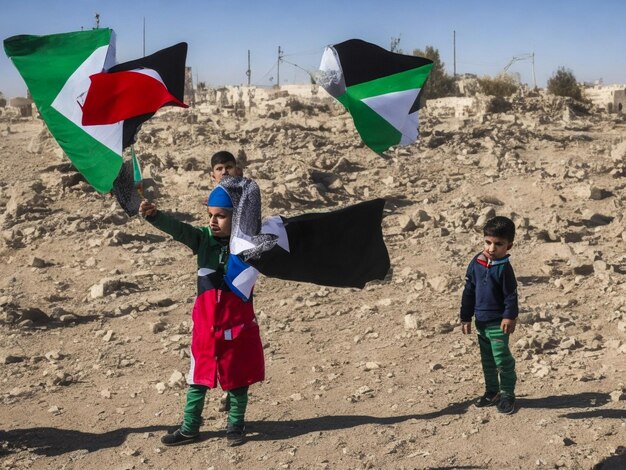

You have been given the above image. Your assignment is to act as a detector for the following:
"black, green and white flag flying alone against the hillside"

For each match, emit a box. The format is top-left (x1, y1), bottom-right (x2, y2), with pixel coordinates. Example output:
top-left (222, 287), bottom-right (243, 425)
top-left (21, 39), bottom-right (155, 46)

top-left (318, 39), bottom-right (432, 153)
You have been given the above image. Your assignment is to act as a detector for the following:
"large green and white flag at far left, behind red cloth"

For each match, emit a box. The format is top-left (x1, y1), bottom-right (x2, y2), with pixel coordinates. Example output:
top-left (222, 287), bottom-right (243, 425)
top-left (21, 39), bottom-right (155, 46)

top-left (4, 29), bottom-right (123, 193)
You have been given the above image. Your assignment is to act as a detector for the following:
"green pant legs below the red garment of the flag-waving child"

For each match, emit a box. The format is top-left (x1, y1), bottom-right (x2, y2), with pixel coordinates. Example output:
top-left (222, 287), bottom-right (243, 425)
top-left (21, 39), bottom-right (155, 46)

top-left (180, 385), bottom-right (248, 435)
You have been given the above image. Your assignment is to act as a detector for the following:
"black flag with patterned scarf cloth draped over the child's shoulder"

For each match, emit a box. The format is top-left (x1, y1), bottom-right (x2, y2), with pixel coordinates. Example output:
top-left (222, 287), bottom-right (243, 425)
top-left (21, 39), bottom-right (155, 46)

top-left (219, 176), bottom-right (390, 302)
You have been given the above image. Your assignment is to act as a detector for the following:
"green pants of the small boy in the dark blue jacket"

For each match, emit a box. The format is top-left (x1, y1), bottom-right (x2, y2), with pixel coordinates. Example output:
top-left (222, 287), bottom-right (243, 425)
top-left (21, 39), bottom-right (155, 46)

top-left (476, 322), bottom-right (517, 397)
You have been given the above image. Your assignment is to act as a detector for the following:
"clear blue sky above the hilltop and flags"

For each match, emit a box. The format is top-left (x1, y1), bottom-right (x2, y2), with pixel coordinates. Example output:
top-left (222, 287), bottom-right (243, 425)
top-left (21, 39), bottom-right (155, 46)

top-left (0, 0), bottom-right (626, 98)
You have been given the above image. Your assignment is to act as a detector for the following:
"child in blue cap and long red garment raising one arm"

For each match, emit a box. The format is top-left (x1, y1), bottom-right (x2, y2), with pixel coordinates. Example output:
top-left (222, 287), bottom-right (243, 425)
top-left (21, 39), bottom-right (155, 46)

top-left (140, 186), bottom-right (265, 446)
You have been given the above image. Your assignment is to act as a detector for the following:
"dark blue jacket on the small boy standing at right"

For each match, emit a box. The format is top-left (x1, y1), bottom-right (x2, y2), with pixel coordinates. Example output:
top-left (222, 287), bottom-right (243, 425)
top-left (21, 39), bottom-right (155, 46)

top-left (461, 253), bottom-right (519, 322)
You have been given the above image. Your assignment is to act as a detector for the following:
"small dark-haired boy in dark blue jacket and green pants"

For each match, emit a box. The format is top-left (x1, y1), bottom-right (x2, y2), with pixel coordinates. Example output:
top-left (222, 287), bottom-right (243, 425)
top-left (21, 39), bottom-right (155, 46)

top-left (461, 217), bottom-right (518, 414)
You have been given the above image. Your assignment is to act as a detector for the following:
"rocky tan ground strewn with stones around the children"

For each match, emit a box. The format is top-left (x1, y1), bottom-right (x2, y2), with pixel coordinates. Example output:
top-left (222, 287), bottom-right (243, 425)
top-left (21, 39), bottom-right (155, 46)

top-left (0, 92), bottom-right (626, 470)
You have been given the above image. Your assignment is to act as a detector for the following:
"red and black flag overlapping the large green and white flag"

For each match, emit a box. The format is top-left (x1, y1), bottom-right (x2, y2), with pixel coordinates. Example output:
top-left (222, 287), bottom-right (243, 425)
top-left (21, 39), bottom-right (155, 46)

top-left (82, 42), bottom-right (188, 147)
